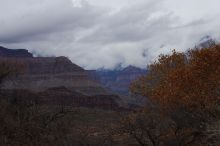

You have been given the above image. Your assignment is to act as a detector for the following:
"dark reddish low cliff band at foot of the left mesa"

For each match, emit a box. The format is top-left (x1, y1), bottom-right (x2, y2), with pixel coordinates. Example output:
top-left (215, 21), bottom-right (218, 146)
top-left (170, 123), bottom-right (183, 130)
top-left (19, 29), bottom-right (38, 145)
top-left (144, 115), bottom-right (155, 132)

top-left (1, 87), bottom-right (120, 110)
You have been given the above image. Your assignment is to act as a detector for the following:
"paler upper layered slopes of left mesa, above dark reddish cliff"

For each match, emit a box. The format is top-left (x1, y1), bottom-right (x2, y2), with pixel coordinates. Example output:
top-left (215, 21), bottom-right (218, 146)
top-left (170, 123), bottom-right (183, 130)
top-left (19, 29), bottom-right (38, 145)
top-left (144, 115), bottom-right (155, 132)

top-left (3, 57), bottom-right (105, 94)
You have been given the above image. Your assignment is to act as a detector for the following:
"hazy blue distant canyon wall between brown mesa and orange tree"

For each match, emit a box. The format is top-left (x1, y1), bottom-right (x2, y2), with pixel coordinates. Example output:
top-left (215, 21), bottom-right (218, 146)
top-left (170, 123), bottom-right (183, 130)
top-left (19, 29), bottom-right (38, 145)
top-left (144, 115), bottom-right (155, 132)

top-left (87, 66), bottom-right (147, 95)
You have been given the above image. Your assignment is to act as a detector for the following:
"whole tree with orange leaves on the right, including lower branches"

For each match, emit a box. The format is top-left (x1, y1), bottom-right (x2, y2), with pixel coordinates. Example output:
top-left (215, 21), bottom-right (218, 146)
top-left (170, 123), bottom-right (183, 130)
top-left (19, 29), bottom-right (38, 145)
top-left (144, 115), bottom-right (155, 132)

top-left (130, 45), bottom-right (220, 145)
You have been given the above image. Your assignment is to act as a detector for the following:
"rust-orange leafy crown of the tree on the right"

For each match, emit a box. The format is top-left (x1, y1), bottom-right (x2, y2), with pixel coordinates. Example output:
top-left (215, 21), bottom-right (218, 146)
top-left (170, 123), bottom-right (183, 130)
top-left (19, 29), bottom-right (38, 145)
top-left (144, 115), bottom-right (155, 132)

top-left (131, 45), bottom-right (220, 111)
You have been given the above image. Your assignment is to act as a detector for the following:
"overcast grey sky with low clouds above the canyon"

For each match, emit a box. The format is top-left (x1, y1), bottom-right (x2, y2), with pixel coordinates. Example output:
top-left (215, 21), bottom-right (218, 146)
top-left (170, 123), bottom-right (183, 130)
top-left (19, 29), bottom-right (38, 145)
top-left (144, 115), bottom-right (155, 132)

top-left (0, 0), bottom-right (220, 69)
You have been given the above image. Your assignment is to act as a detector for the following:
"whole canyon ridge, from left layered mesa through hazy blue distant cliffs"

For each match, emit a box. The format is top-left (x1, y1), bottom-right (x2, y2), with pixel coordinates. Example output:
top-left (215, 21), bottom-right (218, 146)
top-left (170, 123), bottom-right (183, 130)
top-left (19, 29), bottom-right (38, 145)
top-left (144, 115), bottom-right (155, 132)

top-left (0, 47), bottom-right (146, 109)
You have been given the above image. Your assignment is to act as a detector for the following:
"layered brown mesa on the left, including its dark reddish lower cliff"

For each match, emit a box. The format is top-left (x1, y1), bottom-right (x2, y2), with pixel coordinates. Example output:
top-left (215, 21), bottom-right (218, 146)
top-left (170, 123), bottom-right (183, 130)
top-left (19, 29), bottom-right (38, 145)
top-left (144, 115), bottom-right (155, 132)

top-left (2, 46), bottom-right (120, 109)
